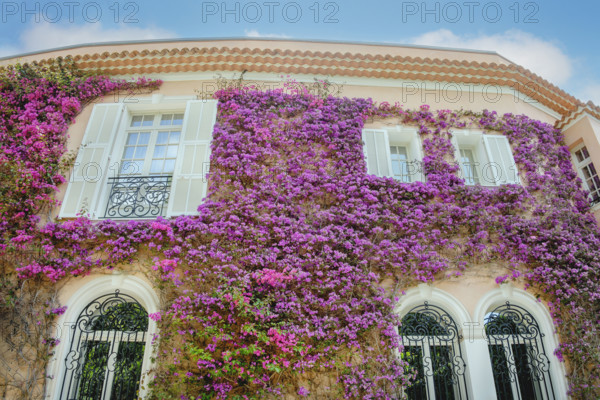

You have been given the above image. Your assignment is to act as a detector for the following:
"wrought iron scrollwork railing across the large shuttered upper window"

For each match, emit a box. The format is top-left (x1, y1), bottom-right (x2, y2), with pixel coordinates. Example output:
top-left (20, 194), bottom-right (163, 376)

top-left (104, 175), bottom-right (172, 219)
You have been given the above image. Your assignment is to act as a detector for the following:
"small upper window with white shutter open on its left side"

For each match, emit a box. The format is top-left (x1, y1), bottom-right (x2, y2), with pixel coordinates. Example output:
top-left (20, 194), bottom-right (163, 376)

top-left (363, 126), bottom-right (423, 183)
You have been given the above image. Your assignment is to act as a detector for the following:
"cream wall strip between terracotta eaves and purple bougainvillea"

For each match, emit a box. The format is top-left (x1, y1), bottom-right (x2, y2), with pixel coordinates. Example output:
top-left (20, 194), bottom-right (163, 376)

top-left (118, 72), bottom-right (561, 124)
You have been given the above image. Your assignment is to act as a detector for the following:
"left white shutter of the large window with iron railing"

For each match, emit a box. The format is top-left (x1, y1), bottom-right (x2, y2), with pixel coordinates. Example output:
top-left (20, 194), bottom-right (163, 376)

top-left (58, 103), bottom-right (123, 218)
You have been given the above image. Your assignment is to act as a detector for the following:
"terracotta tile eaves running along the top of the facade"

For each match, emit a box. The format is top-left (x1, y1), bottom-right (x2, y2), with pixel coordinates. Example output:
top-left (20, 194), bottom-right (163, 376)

top-left (11, 41), bottom-right (588, 126)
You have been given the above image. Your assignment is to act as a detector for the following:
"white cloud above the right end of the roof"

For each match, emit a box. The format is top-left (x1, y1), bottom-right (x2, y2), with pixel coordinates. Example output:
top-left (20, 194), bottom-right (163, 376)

top-left (409, 29), bottom-right (574, 85)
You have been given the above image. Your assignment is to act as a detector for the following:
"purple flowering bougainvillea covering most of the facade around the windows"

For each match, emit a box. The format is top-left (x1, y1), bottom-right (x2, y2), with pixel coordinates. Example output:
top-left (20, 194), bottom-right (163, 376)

top-left (2, 57), bottom-right (600, 399)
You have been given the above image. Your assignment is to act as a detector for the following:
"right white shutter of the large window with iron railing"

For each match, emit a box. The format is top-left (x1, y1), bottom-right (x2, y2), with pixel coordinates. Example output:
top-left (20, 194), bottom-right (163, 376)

top-left (167, 100), bottom-right (217, 217)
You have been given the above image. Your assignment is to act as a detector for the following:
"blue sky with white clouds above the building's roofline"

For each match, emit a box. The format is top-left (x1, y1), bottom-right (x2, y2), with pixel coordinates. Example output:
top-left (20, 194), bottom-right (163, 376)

top-left (0, 0), bottom-right (600, 104)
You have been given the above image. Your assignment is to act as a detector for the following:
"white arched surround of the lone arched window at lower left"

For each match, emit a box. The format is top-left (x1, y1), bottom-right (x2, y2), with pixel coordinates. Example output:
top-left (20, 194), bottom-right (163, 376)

top-left (45, 271), bottom-right (160, 400)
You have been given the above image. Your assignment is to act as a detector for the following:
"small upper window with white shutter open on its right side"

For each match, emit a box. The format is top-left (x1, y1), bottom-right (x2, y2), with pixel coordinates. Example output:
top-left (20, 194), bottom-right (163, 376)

top-left (452, 130), bottom-right (519, 186)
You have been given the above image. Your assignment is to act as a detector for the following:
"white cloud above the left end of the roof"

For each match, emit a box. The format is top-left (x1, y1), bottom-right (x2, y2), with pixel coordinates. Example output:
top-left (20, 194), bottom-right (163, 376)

top-left (0, 22), bottom-right (177, 56)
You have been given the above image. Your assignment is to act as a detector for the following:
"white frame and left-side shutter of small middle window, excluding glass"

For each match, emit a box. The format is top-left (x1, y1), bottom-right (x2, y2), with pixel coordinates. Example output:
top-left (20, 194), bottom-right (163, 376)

top-left (362, 125), bottom-right (425, 183)
